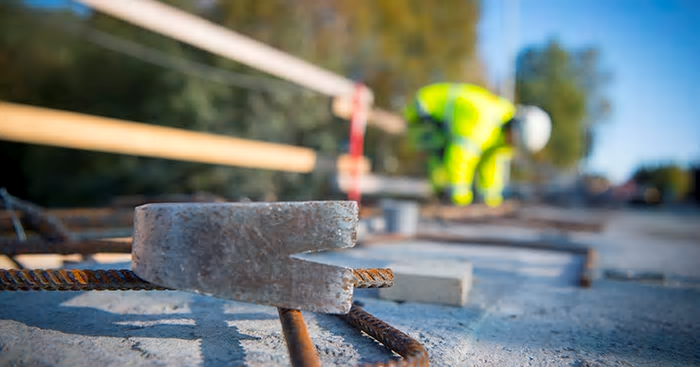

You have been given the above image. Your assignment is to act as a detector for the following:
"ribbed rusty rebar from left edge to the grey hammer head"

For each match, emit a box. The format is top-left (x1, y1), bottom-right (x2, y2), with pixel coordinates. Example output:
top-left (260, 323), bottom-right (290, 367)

top-left (0, 269), bottom-right (166, 291)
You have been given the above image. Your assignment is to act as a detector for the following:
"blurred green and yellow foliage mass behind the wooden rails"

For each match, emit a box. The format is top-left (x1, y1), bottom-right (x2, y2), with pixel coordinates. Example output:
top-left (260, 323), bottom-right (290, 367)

top-left (0, 0), bottom-right (483, 205)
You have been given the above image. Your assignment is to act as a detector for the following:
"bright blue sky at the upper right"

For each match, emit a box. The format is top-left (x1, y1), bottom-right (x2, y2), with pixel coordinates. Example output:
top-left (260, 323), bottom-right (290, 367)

top-left (479, 0), bottom-right (700, 182)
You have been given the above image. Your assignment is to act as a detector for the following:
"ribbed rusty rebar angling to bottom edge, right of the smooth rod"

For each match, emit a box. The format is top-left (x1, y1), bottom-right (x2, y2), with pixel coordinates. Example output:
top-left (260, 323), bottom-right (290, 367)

top-left (339, 304), bottom-right (429, 367)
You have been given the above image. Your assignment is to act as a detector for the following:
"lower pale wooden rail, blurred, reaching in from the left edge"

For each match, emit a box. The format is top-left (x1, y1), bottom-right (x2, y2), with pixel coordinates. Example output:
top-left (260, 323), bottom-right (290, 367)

top-left (0, 101), bottom-right (369, 173)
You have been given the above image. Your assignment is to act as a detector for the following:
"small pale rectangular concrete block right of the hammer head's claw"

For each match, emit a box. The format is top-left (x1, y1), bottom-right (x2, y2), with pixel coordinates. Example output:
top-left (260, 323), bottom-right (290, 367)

top-left (379, 260), bottom-right (472, 306)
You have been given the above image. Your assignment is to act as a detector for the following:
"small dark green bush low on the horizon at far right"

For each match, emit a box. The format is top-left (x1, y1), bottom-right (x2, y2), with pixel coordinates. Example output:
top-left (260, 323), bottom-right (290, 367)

top-left (632, 163), bottom-right (692, 201)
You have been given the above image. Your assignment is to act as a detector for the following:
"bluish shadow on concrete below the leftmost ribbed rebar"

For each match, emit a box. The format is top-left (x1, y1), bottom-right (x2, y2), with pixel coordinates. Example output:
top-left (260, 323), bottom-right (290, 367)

top-left (0, 282), bottom-right (276, 366)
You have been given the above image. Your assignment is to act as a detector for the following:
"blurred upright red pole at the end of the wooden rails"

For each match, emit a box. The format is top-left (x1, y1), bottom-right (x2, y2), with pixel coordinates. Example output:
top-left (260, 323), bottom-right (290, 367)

top-left (348, 83), bottom-right (368, 203)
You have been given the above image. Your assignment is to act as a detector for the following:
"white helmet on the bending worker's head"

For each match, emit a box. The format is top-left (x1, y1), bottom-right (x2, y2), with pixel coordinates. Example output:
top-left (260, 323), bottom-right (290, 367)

top-left (515, 106), bottom-right (552, 153)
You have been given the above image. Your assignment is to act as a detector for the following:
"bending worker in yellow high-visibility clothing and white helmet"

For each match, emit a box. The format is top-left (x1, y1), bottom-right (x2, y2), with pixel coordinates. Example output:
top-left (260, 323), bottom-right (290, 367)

top-left (405, 83), bottom-right (551, 206)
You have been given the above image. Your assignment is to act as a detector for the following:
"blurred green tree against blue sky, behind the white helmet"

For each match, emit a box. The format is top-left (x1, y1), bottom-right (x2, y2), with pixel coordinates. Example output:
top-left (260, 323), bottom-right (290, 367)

top-left (516, 41), bottom-right (610, 168)
